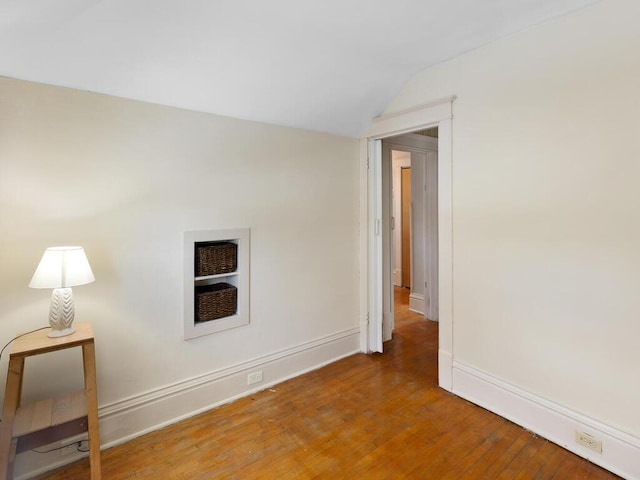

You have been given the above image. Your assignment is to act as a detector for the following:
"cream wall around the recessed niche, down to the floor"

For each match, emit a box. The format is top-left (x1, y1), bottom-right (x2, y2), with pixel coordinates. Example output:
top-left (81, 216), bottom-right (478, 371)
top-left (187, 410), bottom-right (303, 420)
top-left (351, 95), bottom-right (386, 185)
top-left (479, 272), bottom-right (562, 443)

top-left (0, 78), bottom-right (358, 473)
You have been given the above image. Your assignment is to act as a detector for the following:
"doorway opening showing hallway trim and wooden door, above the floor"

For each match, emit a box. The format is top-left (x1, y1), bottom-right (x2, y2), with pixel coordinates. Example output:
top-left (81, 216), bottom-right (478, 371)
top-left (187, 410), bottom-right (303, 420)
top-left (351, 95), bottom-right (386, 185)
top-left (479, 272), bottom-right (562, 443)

top-left (382, 127), bottom-right (438, 342)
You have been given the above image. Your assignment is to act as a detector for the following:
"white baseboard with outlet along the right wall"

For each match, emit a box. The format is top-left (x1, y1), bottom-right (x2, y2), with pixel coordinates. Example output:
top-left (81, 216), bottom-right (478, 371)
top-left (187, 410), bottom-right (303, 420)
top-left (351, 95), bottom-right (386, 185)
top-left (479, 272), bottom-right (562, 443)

top-left (453, 362), bottom-right (640, 480)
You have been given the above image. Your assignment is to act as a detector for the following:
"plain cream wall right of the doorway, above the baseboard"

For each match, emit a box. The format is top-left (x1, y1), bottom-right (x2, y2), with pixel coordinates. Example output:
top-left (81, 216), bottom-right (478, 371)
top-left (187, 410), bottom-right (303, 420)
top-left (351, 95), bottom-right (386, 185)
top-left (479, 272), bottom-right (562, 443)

top-left (387, 0), bottom-right (640, 475)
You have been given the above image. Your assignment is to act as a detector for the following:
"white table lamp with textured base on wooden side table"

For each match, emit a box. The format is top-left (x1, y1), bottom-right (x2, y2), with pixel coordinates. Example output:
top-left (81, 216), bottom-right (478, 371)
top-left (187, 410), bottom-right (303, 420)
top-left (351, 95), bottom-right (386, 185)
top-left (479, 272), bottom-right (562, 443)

top-left (29, 247), bottom-right (95, 337)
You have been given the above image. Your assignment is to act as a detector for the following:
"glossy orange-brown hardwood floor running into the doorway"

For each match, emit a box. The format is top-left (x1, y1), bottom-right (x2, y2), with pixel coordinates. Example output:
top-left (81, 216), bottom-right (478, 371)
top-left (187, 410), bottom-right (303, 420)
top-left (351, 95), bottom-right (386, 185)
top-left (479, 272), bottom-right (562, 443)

top-left (39, 292), bottom-right (619, 480)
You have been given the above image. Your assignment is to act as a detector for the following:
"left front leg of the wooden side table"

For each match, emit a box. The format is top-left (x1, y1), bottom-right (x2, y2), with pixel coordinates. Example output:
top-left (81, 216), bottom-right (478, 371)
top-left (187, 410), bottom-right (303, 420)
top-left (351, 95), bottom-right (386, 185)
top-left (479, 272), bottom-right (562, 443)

top-left (0, 357), bottom-right (24, 480)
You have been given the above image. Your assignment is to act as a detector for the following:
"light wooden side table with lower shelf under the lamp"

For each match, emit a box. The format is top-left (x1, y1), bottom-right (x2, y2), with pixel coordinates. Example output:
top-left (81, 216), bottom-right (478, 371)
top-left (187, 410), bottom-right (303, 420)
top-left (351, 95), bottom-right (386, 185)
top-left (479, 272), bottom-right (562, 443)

top-left (0, 322), bottom-right (101, 480)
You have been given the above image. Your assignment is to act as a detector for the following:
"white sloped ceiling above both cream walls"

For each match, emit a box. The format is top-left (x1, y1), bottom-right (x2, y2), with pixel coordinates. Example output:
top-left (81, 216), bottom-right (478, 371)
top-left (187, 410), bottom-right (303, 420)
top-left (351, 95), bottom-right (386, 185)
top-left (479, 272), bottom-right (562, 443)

top-left (0, 0), bottom-right (597, 136)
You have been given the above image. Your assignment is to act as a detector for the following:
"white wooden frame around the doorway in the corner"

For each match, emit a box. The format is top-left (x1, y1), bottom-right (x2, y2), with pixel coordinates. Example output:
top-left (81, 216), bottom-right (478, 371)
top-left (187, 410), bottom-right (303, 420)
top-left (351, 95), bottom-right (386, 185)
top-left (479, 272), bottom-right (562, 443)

top-left (360, 97), bottom-right (455, 391)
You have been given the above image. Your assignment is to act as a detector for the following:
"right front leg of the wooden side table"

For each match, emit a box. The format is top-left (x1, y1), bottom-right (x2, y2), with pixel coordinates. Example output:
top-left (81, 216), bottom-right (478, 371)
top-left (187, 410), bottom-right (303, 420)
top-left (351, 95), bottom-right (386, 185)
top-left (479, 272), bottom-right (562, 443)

top-left (82, 342), bottom-right (102, 480)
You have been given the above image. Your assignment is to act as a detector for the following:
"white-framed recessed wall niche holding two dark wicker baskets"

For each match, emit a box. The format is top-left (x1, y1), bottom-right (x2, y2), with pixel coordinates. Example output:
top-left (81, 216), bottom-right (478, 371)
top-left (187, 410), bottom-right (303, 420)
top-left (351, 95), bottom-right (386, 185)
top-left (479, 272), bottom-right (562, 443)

top-left (184, 228), bottom-right (250, 340)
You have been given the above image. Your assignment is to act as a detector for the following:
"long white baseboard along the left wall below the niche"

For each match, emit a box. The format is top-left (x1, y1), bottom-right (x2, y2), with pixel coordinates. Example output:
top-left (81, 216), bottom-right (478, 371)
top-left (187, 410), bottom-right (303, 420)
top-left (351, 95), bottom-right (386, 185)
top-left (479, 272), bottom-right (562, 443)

top-left (15, 327), bottom-right (360, 480)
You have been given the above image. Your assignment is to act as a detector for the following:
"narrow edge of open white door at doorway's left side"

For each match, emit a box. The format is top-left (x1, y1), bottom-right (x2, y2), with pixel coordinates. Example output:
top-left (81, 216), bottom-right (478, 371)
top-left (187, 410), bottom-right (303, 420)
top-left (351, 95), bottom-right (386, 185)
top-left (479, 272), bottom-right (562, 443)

top-left (367, 140), bottom-right (383, 353)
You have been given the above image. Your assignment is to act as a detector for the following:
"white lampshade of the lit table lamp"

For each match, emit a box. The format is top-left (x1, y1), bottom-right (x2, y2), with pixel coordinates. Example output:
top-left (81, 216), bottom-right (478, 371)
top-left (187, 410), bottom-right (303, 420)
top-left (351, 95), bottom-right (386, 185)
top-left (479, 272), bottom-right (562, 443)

top-left (29, 247), bottom-right (95, 288)
